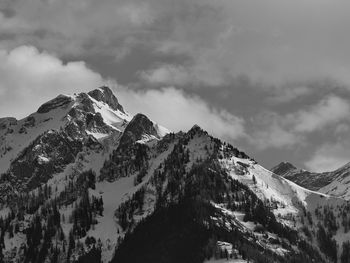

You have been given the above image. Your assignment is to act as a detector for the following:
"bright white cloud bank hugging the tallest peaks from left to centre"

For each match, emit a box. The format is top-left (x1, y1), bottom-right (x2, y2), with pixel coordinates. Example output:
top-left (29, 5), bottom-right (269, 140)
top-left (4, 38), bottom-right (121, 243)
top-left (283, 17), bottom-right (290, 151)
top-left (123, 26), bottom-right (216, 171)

top-left (0, 46), bottom-right (244, 143)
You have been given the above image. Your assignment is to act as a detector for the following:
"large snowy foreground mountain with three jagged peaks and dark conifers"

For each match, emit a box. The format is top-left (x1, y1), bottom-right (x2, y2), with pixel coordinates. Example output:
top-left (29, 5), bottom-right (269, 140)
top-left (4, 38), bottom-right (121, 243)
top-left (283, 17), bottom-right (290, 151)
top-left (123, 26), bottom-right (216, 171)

top-left (0, 87), bottom-right (350, 263)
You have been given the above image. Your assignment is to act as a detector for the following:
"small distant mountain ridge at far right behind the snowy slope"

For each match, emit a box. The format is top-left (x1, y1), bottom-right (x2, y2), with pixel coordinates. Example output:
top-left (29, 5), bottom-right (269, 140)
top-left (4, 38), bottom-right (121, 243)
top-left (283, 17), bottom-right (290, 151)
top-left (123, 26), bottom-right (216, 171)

top-left (271, 162), bottom-right (350, 200)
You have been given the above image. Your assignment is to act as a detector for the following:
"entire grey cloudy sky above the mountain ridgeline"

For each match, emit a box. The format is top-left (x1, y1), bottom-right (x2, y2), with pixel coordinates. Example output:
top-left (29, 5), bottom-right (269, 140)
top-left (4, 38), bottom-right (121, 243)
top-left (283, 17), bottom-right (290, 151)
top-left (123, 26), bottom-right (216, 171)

top-left (0, 0), bottom-right (350, 171)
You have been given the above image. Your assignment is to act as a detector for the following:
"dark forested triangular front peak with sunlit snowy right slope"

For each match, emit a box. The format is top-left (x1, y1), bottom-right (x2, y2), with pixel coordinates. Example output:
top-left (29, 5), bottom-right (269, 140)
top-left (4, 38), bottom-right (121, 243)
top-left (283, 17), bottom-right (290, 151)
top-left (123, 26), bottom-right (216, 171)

top-left (112, 126), bottom-right (344, 262)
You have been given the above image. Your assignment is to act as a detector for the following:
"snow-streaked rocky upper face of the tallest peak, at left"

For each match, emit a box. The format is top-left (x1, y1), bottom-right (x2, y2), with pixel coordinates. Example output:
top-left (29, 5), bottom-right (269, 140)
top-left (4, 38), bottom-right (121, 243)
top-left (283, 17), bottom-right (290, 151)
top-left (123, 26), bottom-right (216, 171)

top-left (0, 87), bottom-right (130, 196)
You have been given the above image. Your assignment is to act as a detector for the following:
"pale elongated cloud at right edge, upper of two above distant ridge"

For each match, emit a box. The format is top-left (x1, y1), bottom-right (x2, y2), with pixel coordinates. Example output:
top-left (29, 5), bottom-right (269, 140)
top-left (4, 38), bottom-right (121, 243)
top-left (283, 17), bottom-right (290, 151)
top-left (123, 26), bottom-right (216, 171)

top-left (250, 95), bottom-right (350, 149)
